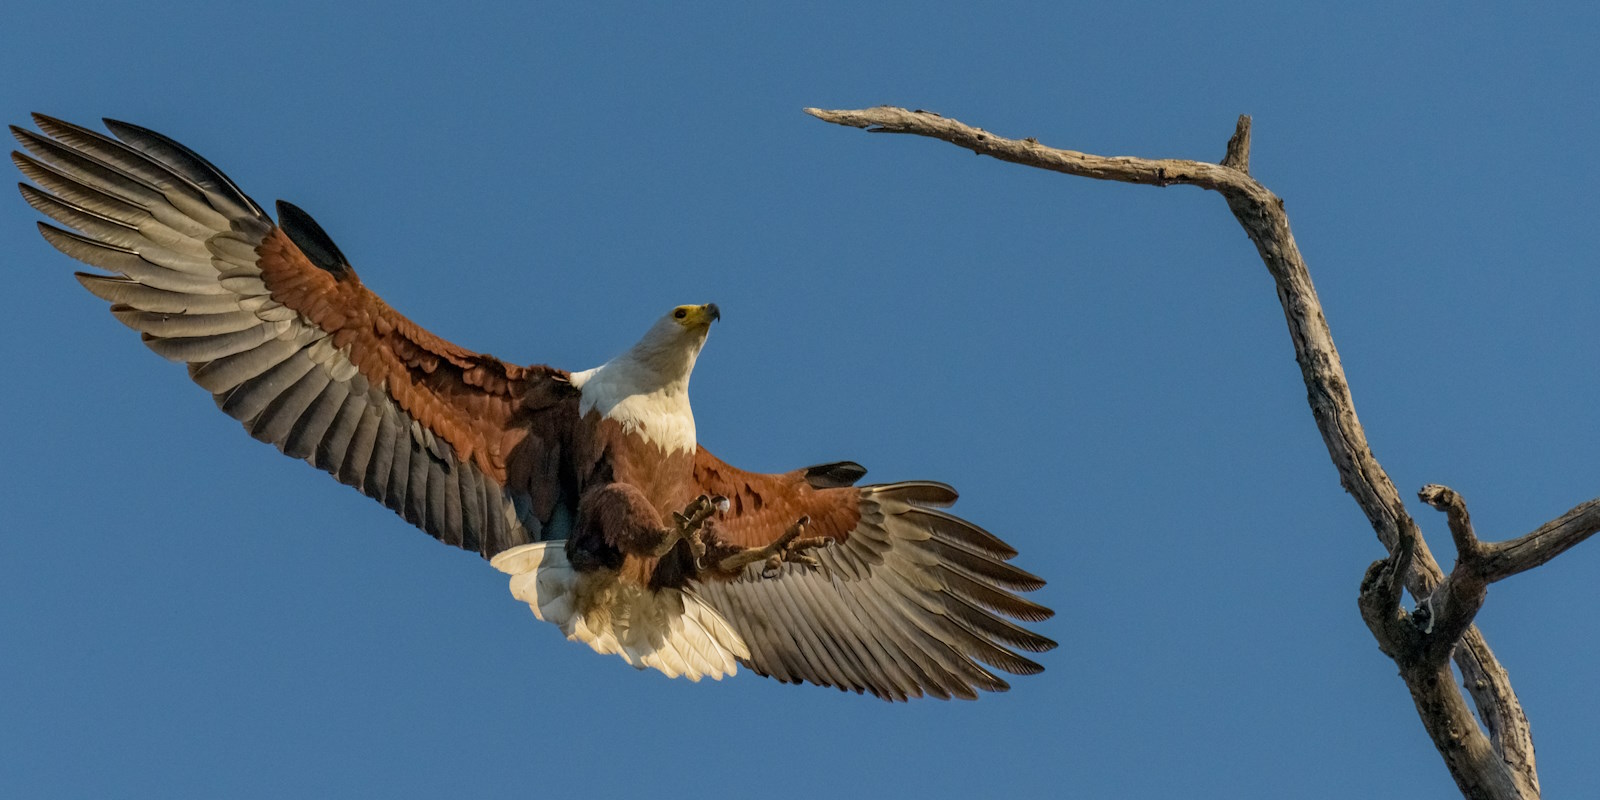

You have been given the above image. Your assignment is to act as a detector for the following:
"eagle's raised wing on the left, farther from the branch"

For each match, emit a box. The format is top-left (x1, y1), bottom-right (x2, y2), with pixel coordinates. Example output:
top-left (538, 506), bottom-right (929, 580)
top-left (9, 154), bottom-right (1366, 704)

top-left (11, 115), bottom-right (576, 555)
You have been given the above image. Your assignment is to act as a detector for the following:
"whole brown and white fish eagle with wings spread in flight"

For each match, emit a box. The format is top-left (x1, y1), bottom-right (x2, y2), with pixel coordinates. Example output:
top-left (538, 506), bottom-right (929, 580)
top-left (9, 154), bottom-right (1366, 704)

top-left (11, 115), bottom-right (1054, 699)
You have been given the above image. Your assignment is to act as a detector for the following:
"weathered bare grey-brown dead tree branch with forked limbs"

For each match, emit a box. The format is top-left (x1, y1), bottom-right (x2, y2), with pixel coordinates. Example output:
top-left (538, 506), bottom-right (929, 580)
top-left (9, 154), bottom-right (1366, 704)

top-left (806, 106), bottom-right (1600, 800)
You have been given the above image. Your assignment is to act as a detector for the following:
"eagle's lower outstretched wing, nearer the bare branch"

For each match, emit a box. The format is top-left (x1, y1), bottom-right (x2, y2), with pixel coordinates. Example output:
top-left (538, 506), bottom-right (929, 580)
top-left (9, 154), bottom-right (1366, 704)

top-left (694, 450), bottom-right (1056, 699)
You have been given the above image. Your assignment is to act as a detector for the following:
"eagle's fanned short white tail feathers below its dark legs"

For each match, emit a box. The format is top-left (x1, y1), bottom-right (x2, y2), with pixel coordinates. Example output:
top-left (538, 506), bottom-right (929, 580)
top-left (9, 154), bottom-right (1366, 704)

top-left (490, 541), bottom-right (750, 682)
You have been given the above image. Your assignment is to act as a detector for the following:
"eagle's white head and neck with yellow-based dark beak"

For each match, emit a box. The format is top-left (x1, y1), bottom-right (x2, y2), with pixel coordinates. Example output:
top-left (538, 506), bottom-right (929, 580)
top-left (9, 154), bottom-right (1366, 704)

top-left (571, 302), bottom-right (722, 451)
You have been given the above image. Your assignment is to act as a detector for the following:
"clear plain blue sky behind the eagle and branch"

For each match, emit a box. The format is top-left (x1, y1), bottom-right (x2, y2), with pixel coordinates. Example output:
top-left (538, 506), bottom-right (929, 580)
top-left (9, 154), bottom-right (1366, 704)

top-left (0, 2), bottom-right (1600, 798)
